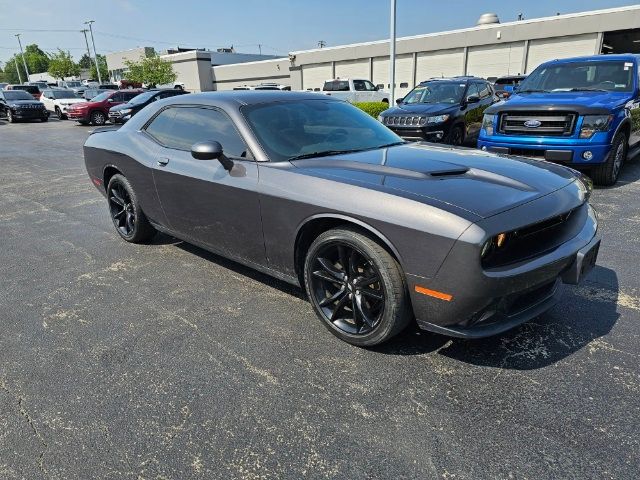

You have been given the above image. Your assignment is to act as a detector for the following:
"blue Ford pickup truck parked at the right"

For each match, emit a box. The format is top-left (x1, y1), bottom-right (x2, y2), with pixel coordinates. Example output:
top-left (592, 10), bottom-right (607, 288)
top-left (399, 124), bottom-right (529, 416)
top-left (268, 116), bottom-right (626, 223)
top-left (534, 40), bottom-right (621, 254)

top-left (478, 55), bottom-right (640, 185)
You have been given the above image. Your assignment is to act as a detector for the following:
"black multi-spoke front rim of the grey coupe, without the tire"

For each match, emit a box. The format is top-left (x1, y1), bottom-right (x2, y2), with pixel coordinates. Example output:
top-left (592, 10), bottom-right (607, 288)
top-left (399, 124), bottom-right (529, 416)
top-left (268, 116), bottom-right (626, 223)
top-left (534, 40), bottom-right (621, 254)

top-left (307, 240), bottom-right (386, 336)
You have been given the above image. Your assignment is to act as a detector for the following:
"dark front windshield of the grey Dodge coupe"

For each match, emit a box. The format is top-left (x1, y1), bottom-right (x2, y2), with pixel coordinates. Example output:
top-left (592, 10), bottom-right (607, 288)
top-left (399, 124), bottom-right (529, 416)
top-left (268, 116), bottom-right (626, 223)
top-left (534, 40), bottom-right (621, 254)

top-left (242, 99), bottom-right (404, 161)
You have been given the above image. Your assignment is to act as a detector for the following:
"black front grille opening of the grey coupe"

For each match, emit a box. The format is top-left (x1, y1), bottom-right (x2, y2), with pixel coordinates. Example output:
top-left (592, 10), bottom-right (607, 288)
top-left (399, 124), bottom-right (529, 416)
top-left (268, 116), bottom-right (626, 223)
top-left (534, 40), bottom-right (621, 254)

top-left (482, 204), bottom-right (588, 269)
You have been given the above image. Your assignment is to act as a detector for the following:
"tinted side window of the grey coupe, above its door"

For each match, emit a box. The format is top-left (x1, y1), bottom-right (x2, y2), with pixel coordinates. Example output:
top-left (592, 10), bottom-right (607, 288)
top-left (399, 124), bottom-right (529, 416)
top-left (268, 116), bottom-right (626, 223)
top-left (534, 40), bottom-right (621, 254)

top-left (146, 107), bottom-right (247, 158)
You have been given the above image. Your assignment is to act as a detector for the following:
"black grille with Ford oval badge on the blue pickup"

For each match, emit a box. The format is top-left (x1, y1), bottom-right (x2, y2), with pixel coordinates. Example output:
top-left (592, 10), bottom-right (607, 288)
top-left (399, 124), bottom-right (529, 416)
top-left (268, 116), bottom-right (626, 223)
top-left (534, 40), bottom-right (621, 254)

top-left (498, 112), bottom-right (577, 136)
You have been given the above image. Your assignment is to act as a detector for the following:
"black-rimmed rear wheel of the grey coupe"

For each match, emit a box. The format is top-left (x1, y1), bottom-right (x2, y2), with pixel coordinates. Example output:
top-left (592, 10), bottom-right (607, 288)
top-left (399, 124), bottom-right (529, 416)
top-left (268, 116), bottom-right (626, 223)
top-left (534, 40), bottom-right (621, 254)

top-left (107, 174), bottom-right (156, 243)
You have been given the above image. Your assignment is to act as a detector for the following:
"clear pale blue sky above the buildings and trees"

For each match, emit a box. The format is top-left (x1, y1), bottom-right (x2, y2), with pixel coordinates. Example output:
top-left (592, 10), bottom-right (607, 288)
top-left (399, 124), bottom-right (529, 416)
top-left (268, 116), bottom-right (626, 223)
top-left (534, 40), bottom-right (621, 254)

top-left (0, 0), bottom-right (637, 64)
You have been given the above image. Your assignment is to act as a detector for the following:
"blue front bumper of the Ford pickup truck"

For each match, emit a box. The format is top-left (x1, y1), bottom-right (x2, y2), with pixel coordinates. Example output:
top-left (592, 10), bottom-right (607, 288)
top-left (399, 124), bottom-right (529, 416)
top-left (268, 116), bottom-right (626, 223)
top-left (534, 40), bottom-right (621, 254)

top-left (478, 137), bottom-right (611, 167)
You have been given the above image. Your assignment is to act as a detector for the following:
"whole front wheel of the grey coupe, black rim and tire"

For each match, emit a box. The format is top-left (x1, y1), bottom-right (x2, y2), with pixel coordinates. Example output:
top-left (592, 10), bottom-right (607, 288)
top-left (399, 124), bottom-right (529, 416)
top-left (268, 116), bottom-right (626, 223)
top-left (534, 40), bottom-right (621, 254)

top-left (304, 228), bottom-right (411, 347)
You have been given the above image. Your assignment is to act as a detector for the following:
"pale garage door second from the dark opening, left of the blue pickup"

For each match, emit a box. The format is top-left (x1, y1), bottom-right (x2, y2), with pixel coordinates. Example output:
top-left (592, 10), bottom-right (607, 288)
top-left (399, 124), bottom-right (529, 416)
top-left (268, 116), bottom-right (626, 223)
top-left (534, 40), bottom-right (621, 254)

top-left (467, 42), bottom-right (524, 78)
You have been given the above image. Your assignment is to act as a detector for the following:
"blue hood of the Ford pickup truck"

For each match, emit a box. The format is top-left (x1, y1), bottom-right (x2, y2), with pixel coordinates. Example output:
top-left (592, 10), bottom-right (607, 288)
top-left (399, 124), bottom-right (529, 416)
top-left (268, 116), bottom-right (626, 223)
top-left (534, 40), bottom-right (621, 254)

top-left (485, 92), bottom-right (631, 114)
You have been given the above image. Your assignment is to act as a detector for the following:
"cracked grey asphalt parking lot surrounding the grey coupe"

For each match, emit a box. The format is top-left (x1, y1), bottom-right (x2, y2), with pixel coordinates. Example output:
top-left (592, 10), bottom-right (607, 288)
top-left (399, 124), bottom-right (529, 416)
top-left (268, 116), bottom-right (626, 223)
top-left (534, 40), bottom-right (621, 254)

top-left (0, 119), bottom-right (640, 479)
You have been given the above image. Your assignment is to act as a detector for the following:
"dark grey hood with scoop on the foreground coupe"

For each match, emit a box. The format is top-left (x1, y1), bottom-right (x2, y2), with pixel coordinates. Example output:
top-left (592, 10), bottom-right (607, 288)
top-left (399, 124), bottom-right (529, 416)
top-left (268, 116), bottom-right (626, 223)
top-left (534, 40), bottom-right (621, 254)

top-left (291, 143), bottom-right (576, 220)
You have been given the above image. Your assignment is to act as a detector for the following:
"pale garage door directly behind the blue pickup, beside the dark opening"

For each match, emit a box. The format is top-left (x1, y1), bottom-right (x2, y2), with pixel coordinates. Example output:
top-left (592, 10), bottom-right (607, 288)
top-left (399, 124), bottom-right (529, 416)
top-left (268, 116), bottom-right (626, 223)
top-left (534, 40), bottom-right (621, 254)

top-left (526, 33), bottom-right (598, 73)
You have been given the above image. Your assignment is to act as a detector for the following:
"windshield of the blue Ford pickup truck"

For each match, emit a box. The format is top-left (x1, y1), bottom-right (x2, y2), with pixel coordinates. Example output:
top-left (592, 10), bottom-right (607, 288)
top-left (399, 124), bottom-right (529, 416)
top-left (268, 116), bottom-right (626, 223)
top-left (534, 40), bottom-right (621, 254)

top-left (518, 61), bottom-right (634, 92)
